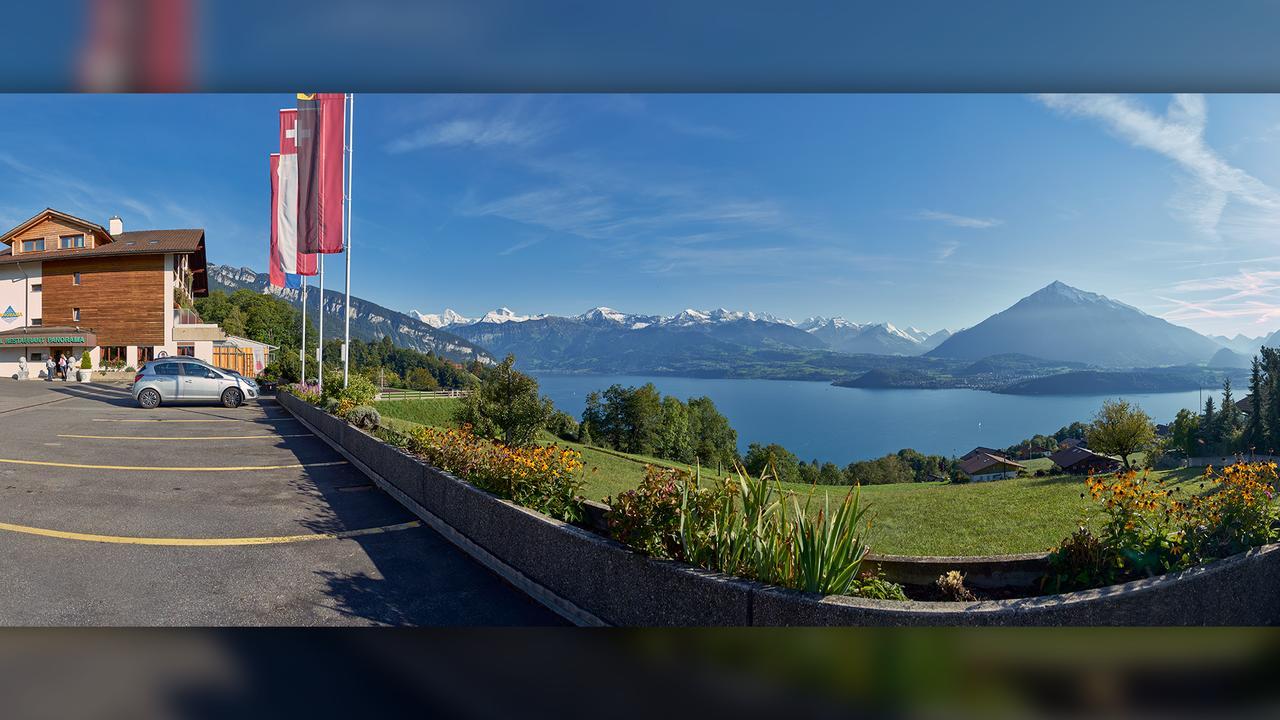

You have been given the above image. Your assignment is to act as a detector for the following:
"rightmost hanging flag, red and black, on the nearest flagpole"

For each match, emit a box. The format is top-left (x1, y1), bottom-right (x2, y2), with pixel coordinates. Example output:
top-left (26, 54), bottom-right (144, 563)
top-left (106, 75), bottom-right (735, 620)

top-left (295, 92), bottom-right (346, 252)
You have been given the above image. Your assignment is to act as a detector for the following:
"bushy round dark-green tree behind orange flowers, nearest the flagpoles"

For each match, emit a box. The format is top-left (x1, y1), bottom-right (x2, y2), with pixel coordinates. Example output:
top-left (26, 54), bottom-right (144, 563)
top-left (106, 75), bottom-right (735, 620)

top-left (456, 355), bottom-right (554, 446)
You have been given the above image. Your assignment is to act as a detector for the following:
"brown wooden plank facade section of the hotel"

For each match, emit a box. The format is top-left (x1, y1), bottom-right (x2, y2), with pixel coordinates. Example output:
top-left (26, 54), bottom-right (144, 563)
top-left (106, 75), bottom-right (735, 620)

top-left (44, 255), bottom-right (173, 346)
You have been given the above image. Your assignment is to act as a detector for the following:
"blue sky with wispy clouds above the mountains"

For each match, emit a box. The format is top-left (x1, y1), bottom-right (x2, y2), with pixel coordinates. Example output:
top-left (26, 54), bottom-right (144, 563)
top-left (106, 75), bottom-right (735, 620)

top-left (0, 95), bottom-right (1280, 334)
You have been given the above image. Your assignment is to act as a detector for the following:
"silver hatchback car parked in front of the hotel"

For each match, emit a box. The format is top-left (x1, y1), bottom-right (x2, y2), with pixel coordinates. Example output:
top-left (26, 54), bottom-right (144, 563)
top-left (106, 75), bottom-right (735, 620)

top-left (132, 357), bottom-right (257, 410)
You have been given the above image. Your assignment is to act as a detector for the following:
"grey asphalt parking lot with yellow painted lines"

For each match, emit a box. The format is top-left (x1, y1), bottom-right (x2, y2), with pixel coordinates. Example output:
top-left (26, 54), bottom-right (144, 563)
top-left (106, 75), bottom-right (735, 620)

top-left (0, 382), bottom-right (562, 625)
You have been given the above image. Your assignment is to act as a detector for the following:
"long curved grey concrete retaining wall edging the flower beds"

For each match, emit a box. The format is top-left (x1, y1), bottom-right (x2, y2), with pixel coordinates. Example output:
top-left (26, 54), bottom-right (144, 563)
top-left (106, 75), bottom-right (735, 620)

top-left (279, 393), bottom-right (1280, 626)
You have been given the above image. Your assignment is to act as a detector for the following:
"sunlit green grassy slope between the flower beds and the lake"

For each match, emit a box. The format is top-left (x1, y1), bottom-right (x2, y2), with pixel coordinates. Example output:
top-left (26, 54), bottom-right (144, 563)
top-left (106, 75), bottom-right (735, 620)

top-left (378, 398), bottom-right (1198, 555)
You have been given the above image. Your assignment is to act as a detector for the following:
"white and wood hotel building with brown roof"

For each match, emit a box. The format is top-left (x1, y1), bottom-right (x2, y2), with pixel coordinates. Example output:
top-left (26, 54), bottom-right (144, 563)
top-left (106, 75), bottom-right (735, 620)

top-left (0, 209), bottom-right (265, 378)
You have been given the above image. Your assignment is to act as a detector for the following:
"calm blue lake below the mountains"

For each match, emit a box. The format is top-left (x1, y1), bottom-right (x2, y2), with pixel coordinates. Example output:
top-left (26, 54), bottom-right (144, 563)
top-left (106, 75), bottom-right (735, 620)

top-left (536, 374), bottom-right (1208, 465)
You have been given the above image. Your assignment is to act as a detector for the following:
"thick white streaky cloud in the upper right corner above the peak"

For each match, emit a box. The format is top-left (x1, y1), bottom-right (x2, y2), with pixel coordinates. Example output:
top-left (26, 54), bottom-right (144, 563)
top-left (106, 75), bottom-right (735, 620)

top-left (1038, 95), bottom-right (1280, 237)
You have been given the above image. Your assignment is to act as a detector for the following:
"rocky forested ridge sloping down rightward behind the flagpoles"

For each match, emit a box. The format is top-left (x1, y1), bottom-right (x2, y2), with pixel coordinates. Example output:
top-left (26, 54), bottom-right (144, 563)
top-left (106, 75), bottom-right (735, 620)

top-left (209, 264), bottom-right (493, 363)
